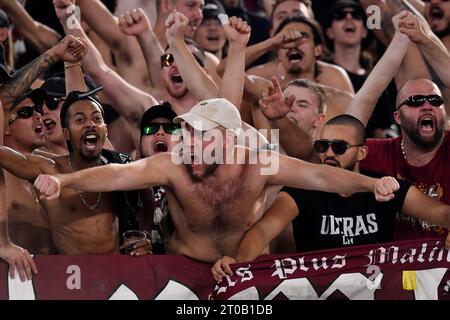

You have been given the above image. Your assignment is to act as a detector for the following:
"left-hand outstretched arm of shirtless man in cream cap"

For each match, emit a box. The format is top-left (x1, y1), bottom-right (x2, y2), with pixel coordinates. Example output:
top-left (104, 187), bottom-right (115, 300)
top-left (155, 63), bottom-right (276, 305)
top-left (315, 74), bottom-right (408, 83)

top-left (34, 153), bottom-right (176, 200)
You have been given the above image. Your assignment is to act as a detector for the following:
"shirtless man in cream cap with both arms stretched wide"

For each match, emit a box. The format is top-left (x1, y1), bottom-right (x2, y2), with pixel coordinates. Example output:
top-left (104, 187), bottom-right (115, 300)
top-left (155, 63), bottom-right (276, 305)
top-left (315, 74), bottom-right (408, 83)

top-left (35, 98), bottom-right (398, 262)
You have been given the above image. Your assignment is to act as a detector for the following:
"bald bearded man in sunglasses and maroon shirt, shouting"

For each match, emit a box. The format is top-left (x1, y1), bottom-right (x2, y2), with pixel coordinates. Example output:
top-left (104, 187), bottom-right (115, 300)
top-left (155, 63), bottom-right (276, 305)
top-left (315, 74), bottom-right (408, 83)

top-left (361, 79), bottom-right (450, 239)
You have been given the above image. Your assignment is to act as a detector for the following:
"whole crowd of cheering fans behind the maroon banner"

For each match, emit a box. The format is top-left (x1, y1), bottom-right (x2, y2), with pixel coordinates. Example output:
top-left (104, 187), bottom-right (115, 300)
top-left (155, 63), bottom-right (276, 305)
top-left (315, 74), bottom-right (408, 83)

top-left (0, 0), bottom-right (450, 280)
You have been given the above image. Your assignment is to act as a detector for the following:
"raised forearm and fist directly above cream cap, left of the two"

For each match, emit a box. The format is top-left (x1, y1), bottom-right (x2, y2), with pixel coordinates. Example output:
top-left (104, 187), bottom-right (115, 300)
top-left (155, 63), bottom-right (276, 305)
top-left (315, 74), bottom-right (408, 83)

top-left (166, 11), bottom-right (219, 100)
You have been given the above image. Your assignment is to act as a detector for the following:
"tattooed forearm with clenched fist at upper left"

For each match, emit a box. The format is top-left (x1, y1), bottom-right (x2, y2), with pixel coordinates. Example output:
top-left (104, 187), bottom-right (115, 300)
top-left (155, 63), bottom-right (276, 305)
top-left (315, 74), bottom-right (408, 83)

top-left (0, 36), bottom-right (87, 113)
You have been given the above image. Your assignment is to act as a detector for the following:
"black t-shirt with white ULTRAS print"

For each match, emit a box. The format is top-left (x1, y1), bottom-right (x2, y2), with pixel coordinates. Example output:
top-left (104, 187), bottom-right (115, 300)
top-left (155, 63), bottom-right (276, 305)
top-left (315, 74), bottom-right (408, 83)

top-left (282, 175), bottom-right (411, 252)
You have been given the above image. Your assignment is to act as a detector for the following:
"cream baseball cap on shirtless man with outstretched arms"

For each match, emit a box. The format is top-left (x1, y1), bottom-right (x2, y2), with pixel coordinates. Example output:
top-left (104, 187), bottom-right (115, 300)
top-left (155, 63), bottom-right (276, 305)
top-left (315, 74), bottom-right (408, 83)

top-left (173, 98), bottom-right (242, 135)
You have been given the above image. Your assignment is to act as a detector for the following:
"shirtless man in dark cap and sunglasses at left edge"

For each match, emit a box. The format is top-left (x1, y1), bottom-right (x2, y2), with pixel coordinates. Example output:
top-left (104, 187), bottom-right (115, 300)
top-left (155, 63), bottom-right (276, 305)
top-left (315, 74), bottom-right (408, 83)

top-left (4, 89), bottom-right (55, 254)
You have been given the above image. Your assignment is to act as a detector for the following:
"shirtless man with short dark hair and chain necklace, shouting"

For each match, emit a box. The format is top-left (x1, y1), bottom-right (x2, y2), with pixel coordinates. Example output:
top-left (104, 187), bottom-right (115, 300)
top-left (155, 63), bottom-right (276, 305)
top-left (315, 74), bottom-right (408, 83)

top-left (0, 89), bottom-right (149, 255)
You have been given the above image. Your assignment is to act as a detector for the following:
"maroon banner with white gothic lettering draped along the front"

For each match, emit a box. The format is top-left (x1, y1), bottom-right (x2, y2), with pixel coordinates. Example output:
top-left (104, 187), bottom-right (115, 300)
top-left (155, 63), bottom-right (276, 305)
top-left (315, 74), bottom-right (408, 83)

top-left (0, 239), bottom-right (450, 300)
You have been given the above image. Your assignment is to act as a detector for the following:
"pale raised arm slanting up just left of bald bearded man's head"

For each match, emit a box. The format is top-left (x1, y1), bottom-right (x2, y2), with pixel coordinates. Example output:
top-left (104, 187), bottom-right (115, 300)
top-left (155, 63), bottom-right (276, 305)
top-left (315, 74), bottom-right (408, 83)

top-left (346, 11), bottom-right (411, 126)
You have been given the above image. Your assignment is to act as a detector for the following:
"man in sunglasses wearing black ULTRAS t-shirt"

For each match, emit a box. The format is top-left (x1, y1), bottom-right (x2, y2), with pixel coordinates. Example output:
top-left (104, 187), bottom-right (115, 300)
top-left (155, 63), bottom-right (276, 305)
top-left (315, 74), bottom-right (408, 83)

top-left (211, 115), bottom-right (450, 281)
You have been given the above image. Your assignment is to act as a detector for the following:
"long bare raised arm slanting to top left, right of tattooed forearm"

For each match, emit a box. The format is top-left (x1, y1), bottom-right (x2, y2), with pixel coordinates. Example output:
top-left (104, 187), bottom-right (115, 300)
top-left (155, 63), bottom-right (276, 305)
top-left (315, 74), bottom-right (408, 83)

top-left (55, 1), bottom-right (157, 126)
